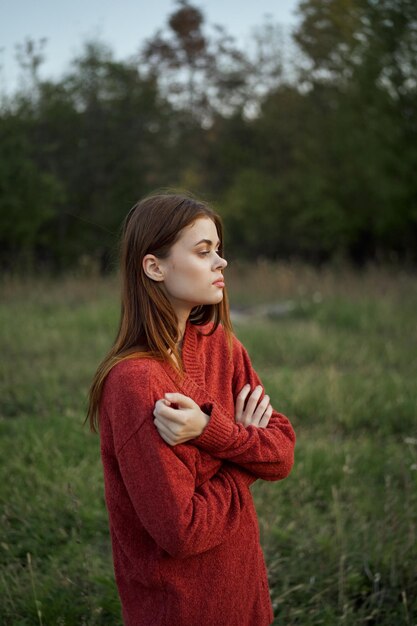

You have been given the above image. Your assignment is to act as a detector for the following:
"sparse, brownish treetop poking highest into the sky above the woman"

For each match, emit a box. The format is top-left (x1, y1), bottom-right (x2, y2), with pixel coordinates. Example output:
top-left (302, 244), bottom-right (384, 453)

top-left (140, 0), bottom-right (248, 119)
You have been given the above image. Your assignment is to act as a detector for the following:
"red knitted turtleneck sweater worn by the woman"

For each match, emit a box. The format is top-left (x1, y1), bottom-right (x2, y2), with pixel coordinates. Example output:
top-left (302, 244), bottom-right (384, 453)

top-left (100, 323), bottom-right (295, 626)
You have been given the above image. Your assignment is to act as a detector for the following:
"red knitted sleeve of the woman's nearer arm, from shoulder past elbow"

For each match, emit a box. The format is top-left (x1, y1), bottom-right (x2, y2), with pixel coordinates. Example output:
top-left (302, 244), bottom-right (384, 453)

top-left (105, 360), bottom-right (254, 558)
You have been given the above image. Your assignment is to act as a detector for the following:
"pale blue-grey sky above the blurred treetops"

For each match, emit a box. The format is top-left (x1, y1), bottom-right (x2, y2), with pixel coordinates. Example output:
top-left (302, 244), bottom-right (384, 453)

top-left (0, 0), bottom-right (299, 93)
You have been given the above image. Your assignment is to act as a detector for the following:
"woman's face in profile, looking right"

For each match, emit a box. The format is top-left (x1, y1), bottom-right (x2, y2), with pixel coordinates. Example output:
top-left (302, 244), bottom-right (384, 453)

top-left (159, 217), bottom-right (227, 315)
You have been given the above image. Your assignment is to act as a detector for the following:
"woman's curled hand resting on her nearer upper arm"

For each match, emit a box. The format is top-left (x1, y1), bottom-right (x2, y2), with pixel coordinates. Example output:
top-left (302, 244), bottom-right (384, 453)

top-left (153, 393), bottom-right (210, 446)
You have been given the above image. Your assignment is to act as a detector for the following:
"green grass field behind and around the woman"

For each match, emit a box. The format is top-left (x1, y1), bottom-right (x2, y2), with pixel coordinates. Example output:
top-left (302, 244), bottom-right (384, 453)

top-left (0, 264), bottom-right (417, 626)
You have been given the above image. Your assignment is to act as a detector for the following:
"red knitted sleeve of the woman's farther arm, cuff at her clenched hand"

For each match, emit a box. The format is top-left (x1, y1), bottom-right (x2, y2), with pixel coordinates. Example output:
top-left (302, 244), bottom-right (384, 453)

top-left (193, 339), bottom-right (295, 480)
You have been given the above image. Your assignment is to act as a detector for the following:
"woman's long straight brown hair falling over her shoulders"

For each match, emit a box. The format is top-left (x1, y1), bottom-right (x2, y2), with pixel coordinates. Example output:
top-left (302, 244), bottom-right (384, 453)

top-left (86, 193), bottom-right (232, 432)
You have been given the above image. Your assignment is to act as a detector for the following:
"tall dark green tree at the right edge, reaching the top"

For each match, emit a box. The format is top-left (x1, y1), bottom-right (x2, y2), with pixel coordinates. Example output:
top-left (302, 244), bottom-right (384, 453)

top-left (295, 0), bottom-right (417, 260)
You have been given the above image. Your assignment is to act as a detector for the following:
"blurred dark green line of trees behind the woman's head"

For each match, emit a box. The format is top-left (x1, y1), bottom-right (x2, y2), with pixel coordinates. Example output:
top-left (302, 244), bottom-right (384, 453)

top-left (0, 0), bottom-right (417, 270)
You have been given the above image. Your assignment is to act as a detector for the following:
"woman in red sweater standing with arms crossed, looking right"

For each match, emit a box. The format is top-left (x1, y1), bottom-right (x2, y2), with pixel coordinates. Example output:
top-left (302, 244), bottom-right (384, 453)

top-left (89, 194), bottom-right (295, 626)
